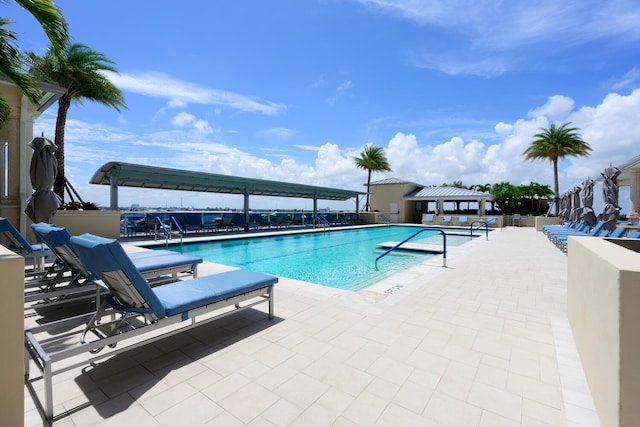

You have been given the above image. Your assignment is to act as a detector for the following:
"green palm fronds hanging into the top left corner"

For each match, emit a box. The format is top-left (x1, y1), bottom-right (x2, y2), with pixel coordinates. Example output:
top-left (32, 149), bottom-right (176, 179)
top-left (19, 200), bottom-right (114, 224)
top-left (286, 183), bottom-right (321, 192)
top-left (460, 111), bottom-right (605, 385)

top-left (0, 0), bottom-right (69, 127)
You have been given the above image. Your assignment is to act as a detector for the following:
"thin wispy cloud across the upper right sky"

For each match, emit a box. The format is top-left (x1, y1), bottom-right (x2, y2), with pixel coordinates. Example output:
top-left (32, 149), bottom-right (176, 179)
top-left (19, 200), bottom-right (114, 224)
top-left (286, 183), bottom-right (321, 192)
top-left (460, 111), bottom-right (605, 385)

top-left (355, 0), bottom-right (640, 76)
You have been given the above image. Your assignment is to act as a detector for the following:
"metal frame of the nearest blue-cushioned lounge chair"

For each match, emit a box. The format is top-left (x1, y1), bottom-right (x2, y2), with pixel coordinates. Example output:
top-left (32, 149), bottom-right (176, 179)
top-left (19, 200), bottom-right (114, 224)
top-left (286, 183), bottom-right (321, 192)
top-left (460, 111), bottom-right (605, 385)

top-left (24, 236), bottom-right (278, 420)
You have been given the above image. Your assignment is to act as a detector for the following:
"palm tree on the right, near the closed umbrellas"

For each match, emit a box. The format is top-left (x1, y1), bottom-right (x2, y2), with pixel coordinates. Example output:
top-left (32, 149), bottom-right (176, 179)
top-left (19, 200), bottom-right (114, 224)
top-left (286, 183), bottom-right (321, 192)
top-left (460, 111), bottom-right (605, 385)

top-left (522, 122), bottom-right (591, 215)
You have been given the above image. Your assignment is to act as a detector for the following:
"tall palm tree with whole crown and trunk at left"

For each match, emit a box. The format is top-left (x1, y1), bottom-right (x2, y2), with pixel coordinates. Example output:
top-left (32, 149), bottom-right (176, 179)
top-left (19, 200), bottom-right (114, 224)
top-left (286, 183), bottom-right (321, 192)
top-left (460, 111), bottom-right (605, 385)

top-left (27, 43), bottom-right (126, 201)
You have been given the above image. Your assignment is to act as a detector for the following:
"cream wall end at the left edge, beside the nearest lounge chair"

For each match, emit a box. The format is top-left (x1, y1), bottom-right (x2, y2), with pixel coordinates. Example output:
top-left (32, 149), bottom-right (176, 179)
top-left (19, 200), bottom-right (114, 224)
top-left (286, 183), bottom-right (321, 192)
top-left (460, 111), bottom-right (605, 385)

top-left (0, 246), bottom-right (24, 426)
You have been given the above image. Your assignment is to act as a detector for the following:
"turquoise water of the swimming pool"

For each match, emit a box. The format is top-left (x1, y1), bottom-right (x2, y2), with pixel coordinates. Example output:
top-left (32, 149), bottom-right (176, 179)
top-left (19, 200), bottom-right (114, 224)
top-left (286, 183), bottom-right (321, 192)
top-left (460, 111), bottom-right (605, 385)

top-left (158, 226), bottom-right (469, 291)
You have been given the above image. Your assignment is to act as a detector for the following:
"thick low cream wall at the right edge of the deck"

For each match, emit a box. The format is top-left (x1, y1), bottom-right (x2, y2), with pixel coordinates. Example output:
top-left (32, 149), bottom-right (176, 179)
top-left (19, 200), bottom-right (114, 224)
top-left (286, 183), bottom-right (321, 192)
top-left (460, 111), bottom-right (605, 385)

top-left (567, 237), bottom-right (640, 426)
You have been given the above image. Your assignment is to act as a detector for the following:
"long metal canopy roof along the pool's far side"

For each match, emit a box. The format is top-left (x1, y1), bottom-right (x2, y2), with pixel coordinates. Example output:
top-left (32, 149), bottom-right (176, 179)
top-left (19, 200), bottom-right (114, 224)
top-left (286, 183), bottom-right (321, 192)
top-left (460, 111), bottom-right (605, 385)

top-left (90, 162), bottom-right (366, 201)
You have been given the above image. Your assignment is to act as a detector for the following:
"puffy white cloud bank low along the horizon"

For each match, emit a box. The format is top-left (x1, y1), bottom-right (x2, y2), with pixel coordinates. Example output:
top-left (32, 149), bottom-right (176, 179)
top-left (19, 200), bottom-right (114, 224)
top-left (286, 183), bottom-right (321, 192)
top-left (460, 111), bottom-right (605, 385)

top-left (34, 89), bottom-right (640, 212)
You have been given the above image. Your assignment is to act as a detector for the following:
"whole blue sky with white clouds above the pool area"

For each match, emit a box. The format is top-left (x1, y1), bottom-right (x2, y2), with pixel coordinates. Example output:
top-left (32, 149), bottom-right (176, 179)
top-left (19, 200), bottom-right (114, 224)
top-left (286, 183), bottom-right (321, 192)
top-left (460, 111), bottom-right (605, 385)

top-left (2, 0), bottom-right (640, 209)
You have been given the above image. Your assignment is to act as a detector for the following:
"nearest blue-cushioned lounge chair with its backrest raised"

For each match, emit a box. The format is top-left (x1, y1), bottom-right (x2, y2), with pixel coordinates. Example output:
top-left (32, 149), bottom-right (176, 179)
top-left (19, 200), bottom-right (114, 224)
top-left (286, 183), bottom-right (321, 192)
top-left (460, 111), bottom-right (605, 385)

top-left (25, 235), bottom-right (278, 419)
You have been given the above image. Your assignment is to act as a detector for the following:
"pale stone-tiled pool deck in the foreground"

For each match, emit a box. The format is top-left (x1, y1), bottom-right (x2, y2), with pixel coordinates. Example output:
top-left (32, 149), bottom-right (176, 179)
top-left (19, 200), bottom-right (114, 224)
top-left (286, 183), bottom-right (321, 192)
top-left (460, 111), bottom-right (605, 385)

top-left (25, 227), bottom-right (600, 427)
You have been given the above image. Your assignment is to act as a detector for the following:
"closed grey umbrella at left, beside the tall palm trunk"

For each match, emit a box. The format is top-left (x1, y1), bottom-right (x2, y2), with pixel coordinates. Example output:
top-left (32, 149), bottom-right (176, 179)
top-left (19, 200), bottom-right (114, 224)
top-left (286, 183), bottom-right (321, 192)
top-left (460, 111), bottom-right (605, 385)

top-left (24, 136), bottom-right (60, 223)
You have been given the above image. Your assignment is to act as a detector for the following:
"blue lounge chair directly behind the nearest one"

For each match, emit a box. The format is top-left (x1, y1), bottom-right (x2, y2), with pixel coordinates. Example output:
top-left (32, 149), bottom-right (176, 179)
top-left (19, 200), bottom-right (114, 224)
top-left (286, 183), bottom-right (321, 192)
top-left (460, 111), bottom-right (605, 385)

top-left (25, 223), bottom-right (202, 303)
